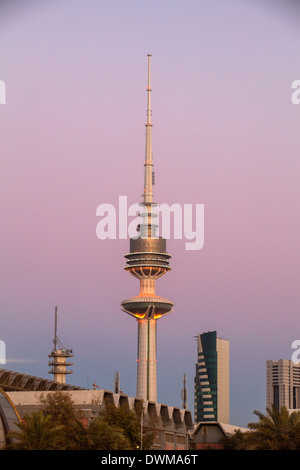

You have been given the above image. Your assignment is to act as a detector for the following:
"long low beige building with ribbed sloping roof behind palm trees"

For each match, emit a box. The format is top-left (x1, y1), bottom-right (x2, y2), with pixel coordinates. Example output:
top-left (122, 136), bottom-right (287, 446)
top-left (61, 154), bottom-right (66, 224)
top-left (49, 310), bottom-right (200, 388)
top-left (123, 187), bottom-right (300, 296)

top-left (0, 369), bottom-right (246, 451)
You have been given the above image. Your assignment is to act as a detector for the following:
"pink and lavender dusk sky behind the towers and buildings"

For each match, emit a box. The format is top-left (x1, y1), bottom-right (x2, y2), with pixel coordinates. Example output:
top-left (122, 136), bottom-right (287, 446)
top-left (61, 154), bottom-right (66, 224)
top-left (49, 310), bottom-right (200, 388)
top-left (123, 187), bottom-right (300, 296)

top-left (0, 0), bottom-right (300, 426)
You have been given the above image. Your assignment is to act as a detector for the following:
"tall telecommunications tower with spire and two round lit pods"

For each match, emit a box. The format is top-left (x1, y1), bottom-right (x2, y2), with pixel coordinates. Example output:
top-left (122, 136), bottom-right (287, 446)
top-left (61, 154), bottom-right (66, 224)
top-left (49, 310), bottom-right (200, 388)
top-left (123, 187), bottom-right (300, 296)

top-left (121, 54), bottom-right (174, 402)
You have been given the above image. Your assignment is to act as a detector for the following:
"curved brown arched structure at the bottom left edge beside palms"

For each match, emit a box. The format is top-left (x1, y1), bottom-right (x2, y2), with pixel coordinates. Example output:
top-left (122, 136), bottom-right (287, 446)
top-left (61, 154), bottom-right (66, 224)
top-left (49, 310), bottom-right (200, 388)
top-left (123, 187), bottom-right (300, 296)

top-left (0, 388), bottom-right (21, 449)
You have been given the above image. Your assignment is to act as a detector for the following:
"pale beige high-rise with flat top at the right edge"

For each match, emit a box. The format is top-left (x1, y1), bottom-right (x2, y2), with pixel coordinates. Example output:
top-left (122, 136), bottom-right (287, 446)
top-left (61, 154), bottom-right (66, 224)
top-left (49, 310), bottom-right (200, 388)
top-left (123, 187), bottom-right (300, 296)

top-left (266, 359), bottom-right (300, 410)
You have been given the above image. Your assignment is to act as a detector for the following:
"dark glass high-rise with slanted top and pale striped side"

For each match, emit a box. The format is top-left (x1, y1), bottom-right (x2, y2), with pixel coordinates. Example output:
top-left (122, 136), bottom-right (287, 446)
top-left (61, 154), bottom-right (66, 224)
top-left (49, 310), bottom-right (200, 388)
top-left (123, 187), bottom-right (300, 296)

top-left (195, 331), bottom-right (229, 424)
